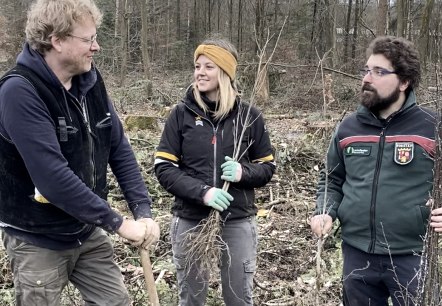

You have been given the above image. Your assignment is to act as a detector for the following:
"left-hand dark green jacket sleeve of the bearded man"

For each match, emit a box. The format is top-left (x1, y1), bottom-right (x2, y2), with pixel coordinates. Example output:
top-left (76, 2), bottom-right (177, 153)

top-left (315, 127), bottom-right (345, 220)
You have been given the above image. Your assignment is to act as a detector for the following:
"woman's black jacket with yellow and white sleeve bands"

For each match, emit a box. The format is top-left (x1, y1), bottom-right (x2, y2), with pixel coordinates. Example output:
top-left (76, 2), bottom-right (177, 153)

top-left (155, 89), bottom-right (275, 220)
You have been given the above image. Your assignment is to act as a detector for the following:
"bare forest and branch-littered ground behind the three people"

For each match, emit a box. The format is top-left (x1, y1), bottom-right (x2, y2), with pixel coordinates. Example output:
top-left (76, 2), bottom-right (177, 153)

top-left (0, 0), bottom-right (442, 306)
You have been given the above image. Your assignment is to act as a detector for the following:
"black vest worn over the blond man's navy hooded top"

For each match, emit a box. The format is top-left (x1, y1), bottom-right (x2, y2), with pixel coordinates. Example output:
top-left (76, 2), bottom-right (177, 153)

top-left (0, 65), bottom-right (112, 235)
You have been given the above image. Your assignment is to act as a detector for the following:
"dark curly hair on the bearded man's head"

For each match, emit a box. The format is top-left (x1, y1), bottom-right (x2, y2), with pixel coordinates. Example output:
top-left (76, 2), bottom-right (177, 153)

top-left (367, 36), bottom-right (421, 91)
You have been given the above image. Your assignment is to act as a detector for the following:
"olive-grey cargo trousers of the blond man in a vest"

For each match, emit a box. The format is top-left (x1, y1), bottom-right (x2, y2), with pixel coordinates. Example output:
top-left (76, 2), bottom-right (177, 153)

top-left (3, 228), bottom-right (130, 306)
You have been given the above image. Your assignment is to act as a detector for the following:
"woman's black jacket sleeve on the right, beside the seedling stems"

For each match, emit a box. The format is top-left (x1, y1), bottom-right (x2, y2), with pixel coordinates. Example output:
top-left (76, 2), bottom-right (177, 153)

top-left (237, 108), bottom-right (276, 189)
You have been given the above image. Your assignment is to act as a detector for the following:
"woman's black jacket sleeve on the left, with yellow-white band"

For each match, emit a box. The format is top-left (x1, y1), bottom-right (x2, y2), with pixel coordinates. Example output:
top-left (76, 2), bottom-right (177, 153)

top-left (155, 105), bottom-right (210, 205)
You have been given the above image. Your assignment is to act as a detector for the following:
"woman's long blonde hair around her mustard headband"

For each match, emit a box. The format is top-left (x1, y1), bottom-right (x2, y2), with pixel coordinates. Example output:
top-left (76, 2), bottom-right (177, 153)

top-left (192, 38), bottom-right (239, 119)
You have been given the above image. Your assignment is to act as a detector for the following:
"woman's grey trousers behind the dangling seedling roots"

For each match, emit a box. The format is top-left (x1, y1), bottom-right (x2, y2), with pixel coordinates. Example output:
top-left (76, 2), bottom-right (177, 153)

top-left (170, 217), bottom-right (258, 306)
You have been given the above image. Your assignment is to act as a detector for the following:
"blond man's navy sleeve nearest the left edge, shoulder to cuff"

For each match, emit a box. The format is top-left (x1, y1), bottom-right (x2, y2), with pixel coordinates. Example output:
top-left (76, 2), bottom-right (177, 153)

top-left (0, 77), bottom-right (123, 232)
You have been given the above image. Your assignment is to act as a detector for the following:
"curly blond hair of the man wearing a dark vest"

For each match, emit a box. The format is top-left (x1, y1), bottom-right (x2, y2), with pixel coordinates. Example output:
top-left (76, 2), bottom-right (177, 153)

top-left (26, 0), bottom-right (102, 54)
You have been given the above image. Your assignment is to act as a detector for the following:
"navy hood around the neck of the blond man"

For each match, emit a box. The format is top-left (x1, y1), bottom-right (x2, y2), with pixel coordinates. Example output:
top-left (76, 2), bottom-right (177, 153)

top-left (17, 43), bottom-right (97, 95)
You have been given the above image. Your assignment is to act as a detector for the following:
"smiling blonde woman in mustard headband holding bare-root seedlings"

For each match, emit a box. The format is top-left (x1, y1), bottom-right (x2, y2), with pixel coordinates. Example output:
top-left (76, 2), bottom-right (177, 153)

top-left (155, 39), bottom-right (275, 306)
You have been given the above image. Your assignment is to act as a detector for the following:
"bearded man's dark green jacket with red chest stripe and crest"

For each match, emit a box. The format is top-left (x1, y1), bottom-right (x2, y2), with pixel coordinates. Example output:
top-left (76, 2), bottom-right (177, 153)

top-left (316, 91), bottom-right (436, 255)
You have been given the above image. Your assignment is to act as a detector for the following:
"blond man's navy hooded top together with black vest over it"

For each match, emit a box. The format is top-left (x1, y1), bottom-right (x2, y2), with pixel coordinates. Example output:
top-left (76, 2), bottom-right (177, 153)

top-left (0, 44), bottom-right (151, 249)
